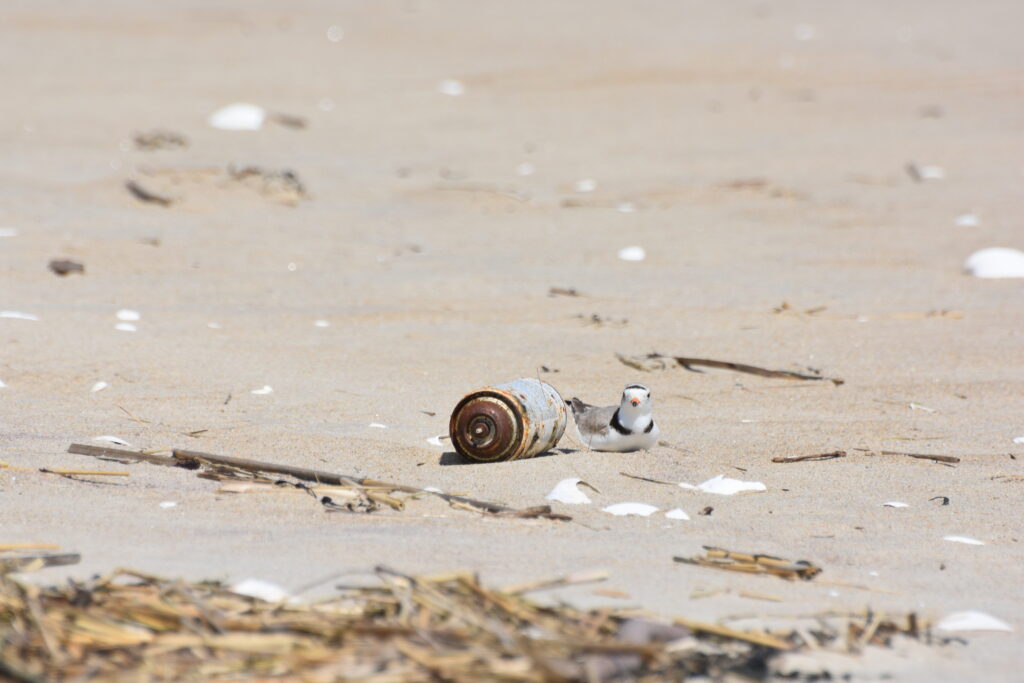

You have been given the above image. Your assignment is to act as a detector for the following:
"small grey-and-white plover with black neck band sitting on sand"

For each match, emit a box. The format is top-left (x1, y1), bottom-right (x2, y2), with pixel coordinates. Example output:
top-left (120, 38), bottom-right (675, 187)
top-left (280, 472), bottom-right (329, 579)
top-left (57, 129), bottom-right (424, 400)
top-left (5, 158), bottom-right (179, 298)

top-left (569, 384), bottom-right (660, 453)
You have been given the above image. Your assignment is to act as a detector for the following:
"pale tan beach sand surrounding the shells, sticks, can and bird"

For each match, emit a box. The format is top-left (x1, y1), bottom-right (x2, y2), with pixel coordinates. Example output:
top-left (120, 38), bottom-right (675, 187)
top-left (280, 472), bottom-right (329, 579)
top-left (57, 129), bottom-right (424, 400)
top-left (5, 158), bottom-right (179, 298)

top-left (0, 0), bottom-right (1024, 681)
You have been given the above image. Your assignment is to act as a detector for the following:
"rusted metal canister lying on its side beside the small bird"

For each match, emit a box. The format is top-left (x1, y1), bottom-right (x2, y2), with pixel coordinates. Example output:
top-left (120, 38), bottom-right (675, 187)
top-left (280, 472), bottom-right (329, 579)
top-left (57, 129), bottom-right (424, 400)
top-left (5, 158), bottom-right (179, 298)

top-left (449, 378), bottom-right (568, 463)
